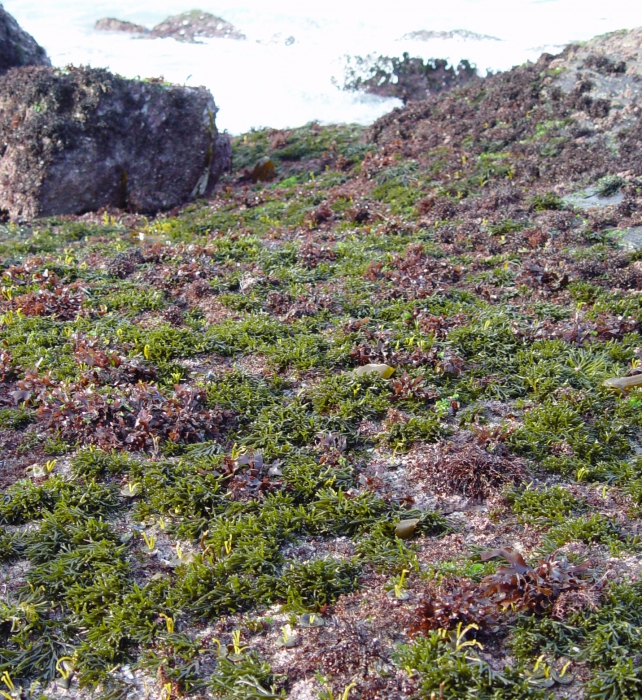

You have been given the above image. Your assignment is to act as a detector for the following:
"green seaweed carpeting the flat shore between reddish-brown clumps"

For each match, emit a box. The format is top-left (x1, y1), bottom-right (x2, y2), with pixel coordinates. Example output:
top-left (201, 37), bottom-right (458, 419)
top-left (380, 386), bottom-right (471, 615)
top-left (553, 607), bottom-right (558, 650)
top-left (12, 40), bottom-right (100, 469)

top-left (0, 110), bottom-right (642, 698)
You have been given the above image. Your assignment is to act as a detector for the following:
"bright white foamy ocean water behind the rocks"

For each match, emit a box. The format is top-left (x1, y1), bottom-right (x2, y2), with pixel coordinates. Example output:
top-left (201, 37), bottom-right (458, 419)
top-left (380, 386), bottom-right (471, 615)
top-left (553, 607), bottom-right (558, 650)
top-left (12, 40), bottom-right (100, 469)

top-left (4, 0), bottom-right (642, 134)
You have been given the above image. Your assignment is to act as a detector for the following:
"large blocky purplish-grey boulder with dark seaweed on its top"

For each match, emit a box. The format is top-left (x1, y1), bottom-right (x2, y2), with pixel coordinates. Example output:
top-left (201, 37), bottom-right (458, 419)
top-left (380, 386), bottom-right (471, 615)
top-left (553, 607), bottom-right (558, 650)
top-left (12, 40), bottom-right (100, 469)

top-left (0, 67), bottom-right (231, 220)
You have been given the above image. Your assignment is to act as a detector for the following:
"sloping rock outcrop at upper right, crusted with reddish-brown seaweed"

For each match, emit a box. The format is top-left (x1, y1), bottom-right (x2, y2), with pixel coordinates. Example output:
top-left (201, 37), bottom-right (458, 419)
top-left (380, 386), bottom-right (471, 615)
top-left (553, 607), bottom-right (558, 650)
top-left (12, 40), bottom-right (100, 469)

top-left (370, 29), bottom-right (642, 180)
